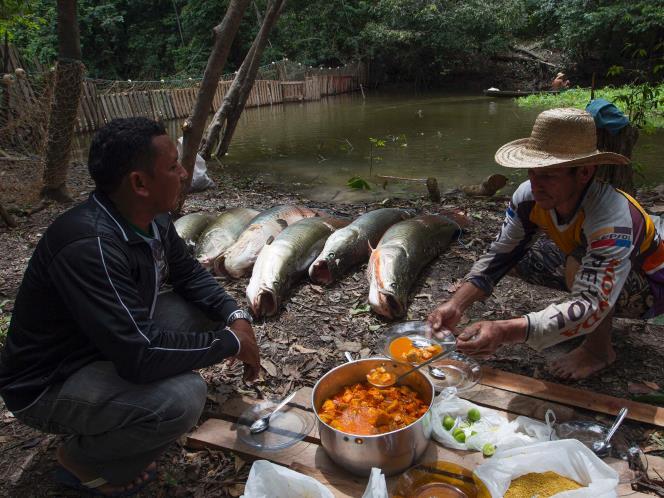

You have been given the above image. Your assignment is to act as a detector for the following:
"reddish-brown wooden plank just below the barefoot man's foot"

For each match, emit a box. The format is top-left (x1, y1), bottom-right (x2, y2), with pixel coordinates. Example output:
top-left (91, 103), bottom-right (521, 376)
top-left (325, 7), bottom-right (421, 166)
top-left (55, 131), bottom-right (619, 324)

top-left (481, 367), bottom-right (664, 427)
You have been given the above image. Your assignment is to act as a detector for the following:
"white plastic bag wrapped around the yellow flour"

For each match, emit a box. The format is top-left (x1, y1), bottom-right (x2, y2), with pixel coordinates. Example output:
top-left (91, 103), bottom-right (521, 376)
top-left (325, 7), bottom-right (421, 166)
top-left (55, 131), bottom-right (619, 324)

top-left (475, 439), bottom-right (618, 498)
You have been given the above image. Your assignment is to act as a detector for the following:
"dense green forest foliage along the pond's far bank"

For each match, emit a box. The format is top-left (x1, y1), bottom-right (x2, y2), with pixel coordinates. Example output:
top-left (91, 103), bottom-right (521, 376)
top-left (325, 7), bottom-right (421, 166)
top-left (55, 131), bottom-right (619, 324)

top-left (0, 0), bottom-right (664, 84)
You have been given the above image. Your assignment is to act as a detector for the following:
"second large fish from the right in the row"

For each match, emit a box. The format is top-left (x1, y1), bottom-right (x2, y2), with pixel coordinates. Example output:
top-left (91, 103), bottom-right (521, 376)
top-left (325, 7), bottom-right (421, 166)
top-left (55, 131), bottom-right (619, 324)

top-left (309, 208), bottom-right (413, 284)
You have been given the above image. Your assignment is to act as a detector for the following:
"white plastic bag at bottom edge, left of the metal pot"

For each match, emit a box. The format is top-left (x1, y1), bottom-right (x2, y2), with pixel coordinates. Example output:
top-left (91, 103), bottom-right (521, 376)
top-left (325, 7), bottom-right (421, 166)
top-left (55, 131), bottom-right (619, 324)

top-left (242, 460), bottom-right (334, 498)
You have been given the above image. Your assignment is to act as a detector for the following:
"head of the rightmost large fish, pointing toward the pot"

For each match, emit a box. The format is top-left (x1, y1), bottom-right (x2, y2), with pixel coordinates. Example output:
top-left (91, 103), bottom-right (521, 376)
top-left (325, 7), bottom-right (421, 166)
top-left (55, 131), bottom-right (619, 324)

top-left (368, 247), bottom-right (408, 319)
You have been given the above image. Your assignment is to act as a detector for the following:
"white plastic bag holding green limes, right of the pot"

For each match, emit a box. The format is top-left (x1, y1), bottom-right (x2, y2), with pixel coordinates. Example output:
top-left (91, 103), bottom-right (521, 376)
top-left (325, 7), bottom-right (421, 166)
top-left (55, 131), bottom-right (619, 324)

top-left (431, 389), bottom-right (551, 451)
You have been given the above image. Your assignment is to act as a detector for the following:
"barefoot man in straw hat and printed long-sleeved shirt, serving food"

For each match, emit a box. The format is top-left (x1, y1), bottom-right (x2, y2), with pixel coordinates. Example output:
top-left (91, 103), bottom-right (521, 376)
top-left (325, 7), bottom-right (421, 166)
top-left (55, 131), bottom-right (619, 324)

top-left (429, 109), bottom-right (664, 379)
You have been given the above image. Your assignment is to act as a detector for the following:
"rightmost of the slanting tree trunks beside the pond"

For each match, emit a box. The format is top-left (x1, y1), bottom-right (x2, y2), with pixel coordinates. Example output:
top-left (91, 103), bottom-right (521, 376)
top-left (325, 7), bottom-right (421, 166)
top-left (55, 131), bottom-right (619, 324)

top-left (216, 0), bottom-right (286, 157)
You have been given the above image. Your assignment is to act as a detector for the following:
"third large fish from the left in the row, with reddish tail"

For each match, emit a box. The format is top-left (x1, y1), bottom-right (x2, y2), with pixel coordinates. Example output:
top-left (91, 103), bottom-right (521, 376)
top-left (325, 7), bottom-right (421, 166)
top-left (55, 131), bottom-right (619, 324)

top-left (222, 205), bottom-right (317, 278)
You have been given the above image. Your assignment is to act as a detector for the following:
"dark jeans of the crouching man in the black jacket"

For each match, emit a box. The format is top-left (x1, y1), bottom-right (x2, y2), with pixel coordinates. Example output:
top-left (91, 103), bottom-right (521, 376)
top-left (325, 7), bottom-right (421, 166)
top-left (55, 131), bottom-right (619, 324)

top-left (14, 293), bottom-right (218, 484)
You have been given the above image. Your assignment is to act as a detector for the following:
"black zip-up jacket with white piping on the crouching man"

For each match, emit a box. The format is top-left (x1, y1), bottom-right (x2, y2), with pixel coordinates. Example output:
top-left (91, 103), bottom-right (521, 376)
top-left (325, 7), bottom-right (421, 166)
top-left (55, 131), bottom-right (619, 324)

top-left (0, 192), bottom-right (244, 411)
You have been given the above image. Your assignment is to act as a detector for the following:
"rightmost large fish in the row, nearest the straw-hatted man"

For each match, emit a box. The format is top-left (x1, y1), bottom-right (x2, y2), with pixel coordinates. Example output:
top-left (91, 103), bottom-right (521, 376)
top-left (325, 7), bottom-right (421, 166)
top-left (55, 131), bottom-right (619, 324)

top-left (367, 215), bottom-right (459, 319)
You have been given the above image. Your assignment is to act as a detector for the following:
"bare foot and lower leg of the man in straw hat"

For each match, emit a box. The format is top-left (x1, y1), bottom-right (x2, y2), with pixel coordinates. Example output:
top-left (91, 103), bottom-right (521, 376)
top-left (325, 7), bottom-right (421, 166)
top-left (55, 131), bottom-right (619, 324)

top-left (549, 313), bottom-right (616, 380)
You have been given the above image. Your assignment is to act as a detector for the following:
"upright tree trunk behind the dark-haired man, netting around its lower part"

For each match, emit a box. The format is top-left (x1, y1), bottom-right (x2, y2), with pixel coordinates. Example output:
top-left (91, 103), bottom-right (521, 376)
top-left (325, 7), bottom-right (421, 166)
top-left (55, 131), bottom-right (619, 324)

top-left (41, 0), bottom-right (84, 202)
